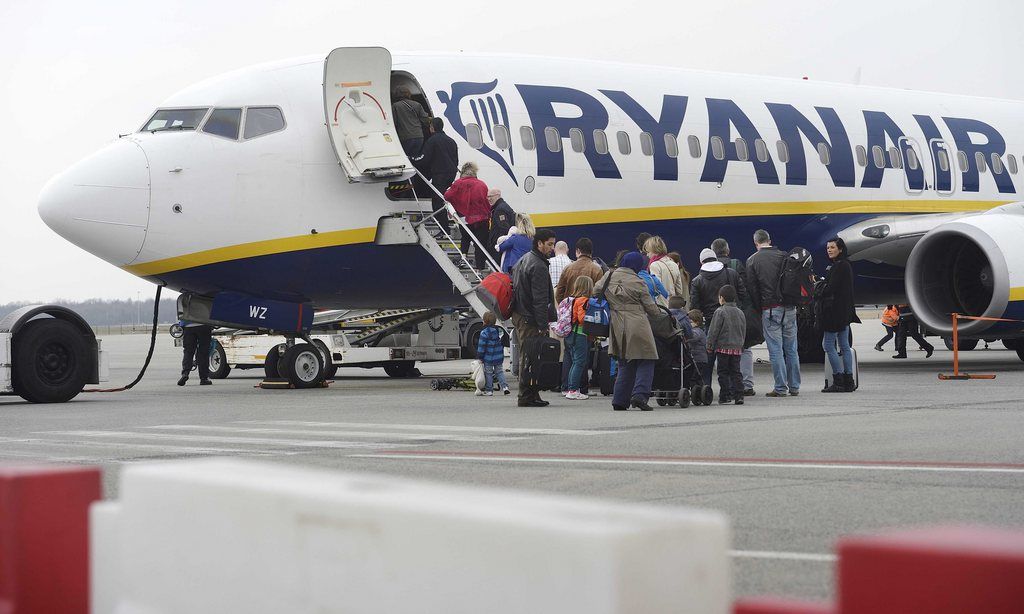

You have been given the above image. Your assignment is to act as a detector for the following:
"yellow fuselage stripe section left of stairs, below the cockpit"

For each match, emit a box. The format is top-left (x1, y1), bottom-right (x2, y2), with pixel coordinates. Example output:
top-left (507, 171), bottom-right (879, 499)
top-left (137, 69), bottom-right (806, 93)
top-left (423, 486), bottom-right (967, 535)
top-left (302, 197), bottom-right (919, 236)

top-left (124, 227), bottom-right (377, 277)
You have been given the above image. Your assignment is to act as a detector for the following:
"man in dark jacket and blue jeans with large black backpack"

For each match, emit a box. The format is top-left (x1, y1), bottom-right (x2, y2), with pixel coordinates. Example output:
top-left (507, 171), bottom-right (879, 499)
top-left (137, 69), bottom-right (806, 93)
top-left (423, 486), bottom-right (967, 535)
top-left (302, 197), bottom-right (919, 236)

top-left (746, 230), bottom-right (800, 398)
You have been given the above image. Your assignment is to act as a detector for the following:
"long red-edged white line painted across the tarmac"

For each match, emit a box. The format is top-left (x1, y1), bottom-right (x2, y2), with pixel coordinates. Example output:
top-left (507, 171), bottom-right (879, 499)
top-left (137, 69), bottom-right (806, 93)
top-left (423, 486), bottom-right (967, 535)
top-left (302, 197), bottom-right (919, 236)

top-left (351, 450), bottom-right (1024, 474)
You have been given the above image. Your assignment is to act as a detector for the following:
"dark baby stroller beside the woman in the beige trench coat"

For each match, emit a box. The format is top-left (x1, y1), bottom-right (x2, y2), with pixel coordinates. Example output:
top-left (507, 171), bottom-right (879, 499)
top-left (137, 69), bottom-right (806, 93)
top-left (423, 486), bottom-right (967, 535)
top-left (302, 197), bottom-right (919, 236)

top-left (650, 307), bottom-right (715, 407)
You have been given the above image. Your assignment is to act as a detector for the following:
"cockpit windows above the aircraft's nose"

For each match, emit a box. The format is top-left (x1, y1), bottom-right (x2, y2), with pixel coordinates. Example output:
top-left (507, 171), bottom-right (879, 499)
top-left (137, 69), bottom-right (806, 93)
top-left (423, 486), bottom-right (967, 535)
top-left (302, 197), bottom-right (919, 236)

top-left (142, 106), bottom-right (285, 140)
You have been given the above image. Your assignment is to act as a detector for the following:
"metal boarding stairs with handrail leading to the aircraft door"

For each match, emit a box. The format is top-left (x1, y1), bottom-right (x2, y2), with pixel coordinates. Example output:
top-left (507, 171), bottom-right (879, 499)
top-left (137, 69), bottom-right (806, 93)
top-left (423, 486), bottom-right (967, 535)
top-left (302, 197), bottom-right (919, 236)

top-left (404, 171), bottom-right (510, 321)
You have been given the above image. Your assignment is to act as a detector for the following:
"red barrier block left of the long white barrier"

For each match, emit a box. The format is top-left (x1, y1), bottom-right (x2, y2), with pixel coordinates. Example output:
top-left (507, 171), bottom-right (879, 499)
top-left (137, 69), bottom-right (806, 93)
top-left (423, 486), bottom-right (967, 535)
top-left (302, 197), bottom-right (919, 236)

top-left (0, 466), bottom-right (100, 614)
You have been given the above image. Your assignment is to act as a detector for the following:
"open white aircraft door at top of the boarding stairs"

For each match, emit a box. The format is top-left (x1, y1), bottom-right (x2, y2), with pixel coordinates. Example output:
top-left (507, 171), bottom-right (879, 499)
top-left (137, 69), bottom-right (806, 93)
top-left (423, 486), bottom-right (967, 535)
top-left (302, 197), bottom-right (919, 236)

top-left (324, 47), bottom-right (416, 182)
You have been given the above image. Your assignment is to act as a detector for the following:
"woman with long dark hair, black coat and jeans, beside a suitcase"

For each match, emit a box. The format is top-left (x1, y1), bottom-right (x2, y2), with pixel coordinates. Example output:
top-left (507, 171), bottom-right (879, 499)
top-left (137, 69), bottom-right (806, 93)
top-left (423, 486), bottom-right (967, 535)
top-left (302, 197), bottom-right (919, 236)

top-left (820, 236), bottom-right (860, 392)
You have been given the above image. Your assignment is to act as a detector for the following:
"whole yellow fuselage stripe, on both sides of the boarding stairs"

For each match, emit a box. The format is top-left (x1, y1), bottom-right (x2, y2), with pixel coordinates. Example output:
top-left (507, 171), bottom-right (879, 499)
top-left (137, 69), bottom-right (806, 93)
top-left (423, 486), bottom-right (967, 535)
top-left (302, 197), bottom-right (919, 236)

top-left (123, 200), bottom-right (1009, 277)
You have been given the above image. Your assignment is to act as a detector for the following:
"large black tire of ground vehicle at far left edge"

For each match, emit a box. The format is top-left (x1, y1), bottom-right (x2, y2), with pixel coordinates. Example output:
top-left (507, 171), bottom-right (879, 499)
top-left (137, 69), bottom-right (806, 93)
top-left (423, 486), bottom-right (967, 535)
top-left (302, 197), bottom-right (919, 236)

top-left (11, 318), bottom-right (95, 403)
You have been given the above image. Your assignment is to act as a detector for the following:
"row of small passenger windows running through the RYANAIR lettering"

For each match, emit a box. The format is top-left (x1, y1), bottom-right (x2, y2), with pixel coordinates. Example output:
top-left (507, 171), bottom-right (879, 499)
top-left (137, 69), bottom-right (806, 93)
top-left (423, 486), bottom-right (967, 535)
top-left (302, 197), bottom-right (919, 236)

top-left (466, 124), bottom-right (1018, 174)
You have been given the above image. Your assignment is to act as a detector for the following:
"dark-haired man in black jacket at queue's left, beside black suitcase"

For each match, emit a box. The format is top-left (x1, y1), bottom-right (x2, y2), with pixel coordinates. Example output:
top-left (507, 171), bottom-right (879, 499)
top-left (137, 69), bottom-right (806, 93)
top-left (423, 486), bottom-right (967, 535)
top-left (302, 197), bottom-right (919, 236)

top-left (512, 228), bottom-right (557, 407)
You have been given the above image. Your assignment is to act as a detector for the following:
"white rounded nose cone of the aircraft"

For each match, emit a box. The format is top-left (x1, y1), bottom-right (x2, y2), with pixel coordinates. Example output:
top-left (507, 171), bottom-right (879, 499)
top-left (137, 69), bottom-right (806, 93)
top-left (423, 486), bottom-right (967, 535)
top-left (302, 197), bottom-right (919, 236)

top-left (39, 138), bottom-right (150, 266)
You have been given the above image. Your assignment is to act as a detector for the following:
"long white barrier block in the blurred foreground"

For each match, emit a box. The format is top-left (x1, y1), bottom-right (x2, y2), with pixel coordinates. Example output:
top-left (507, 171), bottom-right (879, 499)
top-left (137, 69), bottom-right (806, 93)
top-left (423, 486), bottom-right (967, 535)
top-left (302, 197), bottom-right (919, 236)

top-left (95, 458), bottom-right (731, 614)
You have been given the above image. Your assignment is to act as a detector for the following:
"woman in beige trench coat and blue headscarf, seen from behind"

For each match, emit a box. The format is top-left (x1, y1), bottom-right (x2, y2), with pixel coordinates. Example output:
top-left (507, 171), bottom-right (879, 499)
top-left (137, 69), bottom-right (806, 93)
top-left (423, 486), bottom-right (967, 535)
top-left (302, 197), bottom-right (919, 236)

top-left (595, 252), bottom-right (671, 411)
